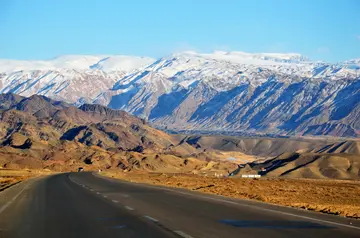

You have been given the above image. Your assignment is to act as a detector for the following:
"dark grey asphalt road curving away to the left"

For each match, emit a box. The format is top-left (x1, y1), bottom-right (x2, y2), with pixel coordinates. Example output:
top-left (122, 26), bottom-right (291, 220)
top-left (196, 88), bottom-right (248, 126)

top-left (0, 173), bottom-right (360, 238)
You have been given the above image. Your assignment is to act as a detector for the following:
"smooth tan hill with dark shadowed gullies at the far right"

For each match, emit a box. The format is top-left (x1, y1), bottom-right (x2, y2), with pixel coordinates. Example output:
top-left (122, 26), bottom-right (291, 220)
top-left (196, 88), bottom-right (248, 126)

top-left (235, 141), bottom-right (360, 180)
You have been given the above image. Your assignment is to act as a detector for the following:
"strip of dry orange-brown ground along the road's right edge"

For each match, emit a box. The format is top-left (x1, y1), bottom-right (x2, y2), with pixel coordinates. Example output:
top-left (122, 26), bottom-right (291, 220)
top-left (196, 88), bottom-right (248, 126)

top-left (101, 172), bottom-right (360, 219)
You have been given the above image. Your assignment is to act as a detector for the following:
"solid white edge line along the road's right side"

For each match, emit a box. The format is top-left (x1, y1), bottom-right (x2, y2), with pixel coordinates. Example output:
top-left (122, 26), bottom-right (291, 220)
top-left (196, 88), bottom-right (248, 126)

top-left (172, 190), bottom-right (360, 230)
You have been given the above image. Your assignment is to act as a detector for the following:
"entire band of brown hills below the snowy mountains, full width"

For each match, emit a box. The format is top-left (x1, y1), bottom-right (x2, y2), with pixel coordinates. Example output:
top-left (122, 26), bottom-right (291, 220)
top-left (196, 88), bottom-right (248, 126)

top-left (0, 93), bottom-right (360, 179)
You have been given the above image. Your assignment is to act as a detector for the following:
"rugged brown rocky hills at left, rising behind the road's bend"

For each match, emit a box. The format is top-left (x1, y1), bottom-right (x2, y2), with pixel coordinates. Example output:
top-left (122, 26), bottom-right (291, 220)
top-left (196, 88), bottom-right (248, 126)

top-left (0, 94), bottom-right (236, 172)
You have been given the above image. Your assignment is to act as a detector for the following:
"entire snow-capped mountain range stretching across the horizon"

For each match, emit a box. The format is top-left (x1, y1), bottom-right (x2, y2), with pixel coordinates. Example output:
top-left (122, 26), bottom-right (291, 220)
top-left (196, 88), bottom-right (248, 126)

top-left (0, 52), bottom-right (360, 137)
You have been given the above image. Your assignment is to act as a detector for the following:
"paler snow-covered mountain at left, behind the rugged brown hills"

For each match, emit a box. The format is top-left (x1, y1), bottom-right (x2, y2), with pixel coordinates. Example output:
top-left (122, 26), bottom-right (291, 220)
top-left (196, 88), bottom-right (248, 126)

top-left (0, 55), bottom-right (155, 102)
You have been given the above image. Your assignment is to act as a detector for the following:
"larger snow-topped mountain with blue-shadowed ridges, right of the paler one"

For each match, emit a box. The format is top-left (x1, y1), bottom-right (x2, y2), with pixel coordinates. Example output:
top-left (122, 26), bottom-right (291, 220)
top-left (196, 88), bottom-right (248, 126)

top-left (95, 52), bottom-right (360, 137)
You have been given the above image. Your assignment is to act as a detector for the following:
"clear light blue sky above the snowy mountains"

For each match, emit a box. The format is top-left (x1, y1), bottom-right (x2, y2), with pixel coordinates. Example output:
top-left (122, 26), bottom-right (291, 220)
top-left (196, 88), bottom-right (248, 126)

top-left (0, 0), bottom-right (360, 62)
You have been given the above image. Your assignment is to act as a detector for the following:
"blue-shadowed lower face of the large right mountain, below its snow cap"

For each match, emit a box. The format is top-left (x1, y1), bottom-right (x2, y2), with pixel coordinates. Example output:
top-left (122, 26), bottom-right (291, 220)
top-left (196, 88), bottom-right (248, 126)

top-left (122, 78), bottom-right (360, 137)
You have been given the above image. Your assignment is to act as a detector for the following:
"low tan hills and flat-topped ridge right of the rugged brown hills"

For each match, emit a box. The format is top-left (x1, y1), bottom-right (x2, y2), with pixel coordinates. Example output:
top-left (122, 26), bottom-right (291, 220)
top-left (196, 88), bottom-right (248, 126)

top-left (177, 135), bottom-right (360, 180)
